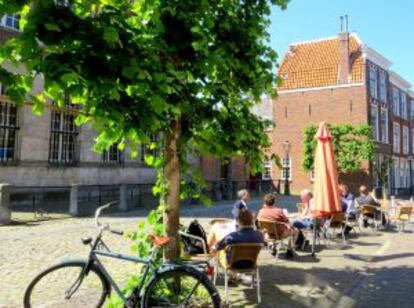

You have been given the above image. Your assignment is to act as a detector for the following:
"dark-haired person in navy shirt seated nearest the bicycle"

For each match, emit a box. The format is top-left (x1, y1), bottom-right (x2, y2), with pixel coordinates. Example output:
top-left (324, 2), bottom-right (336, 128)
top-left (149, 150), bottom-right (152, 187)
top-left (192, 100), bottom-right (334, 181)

top-left (210, 210), bottom-right (265, 262)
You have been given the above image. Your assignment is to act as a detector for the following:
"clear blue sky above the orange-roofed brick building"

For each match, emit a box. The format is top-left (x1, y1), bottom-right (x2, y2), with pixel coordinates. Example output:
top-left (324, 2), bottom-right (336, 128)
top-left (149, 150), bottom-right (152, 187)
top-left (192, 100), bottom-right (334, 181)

top-left (270, 0), bottom-right (414, 86)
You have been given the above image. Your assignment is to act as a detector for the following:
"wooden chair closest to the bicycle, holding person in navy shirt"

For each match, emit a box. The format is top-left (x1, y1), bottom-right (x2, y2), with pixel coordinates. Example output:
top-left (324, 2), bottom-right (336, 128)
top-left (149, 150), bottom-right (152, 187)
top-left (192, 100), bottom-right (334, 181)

top-left (213, 243), bottom-right (263, 304)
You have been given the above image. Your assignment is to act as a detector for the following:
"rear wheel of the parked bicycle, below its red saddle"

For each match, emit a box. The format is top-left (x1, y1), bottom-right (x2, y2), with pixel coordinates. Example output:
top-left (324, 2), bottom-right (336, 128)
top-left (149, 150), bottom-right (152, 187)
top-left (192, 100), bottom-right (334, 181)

top-left (141, 268), bottom-right (220, 308)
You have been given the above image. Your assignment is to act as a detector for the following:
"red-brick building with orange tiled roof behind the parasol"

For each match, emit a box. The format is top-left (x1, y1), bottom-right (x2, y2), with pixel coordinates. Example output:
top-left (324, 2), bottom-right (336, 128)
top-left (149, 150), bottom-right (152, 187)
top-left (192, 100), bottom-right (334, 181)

top-left (272, 32), bottom-right (414, 194)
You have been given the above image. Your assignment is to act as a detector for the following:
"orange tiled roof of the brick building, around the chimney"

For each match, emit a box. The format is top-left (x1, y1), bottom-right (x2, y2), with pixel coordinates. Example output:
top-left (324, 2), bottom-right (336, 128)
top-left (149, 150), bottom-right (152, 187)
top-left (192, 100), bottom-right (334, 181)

top-left (278, 35), bottom-right (363, 90)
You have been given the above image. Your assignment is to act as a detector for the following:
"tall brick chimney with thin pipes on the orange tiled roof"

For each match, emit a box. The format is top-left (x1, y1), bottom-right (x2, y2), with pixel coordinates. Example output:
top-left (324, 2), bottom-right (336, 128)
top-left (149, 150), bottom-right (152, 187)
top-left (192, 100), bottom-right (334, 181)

top-left (338, 15), bottom-right (351, 84)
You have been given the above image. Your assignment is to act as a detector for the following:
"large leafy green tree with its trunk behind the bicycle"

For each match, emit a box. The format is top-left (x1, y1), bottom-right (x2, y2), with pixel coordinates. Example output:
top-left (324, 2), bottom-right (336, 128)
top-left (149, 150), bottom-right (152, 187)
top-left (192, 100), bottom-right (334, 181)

top-left (0, 0), bottom-right (287, 258)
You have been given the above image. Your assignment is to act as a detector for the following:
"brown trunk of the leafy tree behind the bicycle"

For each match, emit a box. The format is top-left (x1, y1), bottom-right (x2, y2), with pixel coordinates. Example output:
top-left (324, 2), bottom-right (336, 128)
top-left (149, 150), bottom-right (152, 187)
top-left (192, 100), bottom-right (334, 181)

top-left (164, 119), bottom-right (181, 261)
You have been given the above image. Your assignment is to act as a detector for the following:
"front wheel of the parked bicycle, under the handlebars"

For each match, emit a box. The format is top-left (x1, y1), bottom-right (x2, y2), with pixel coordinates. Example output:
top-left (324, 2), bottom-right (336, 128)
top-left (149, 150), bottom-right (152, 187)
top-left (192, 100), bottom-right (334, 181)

top-left (24, 261), bottom-right (110, 308)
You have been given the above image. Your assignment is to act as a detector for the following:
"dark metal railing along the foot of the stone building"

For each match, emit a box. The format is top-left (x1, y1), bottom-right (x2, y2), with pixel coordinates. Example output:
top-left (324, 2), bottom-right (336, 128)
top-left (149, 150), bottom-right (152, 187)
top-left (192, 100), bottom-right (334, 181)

top-left (10, 179), bottom-right (280, 218)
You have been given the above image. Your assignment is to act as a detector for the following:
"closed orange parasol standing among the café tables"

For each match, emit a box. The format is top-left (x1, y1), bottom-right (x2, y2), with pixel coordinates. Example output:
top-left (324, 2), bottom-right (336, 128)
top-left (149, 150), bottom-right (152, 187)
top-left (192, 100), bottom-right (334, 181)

top-left (312, 122), bottom-right (342, 217)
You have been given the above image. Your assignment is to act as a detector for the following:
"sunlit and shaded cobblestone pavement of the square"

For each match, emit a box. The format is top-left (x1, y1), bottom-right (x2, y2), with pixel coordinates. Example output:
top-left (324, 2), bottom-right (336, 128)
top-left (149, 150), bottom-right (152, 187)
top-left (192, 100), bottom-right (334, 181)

top-left (0, 199), bottom-right (414, 308)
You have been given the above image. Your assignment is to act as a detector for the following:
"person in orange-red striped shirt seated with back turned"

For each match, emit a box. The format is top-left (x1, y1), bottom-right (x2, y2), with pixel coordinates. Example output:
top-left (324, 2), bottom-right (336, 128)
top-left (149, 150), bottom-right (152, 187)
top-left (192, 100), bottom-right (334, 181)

top-left (257, 194), bottom-right (303, 256)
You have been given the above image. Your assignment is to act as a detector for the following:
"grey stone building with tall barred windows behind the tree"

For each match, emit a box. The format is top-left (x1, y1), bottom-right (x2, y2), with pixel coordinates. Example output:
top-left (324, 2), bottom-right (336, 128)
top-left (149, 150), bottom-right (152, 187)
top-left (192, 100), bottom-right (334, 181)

top-left (0, 15), bottom-right (256, 195)
